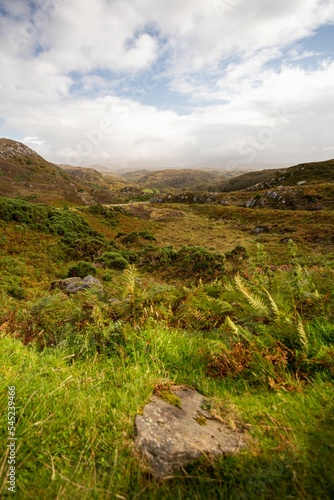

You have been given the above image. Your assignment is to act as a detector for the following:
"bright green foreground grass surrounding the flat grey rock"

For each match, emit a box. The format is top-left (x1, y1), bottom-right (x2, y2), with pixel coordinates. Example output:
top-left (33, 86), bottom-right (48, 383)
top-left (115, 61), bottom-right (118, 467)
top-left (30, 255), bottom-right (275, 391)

top-left (0, 326), bottom-right (333, 499)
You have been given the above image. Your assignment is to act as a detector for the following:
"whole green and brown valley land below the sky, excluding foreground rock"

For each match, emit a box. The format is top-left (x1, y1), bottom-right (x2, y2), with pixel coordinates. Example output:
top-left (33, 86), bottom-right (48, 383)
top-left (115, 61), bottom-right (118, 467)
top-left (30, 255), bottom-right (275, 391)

top-left (0, 139), bottom-right (334, 499)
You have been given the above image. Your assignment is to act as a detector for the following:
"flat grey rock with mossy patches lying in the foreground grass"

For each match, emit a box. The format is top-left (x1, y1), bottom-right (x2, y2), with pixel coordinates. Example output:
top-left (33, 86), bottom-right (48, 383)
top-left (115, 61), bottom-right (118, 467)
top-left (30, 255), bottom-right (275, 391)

top-left (135, 387), bottom-right (245, 478)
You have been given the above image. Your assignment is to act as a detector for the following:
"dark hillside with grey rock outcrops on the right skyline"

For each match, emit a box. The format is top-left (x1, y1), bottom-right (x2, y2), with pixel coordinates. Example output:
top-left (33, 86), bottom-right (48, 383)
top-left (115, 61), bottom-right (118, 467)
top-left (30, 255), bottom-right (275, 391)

top-left (153, 160), bottom-right (334, 210)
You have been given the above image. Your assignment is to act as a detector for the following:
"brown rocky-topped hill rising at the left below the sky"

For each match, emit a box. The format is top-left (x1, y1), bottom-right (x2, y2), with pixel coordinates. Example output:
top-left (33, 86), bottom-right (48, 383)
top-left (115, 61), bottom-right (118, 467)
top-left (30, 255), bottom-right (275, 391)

top-left (0, 139), bottom-right (133, 205)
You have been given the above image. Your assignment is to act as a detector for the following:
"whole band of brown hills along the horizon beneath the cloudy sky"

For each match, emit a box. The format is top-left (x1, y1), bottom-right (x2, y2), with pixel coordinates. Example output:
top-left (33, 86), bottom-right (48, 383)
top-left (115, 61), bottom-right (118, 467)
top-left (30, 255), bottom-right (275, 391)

top-left (0, 139), bottom-right (334, 210)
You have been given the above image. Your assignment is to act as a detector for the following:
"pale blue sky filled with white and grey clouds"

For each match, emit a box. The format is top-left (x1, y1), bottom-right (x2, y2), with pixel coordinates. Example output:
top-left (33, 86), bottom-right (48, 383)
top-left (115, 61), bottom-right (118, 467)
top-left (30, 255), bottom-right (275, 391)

top-left (0, 0), bottom-right (334, 169)
